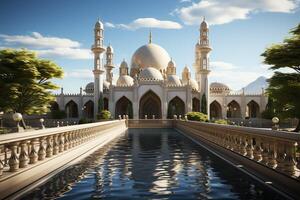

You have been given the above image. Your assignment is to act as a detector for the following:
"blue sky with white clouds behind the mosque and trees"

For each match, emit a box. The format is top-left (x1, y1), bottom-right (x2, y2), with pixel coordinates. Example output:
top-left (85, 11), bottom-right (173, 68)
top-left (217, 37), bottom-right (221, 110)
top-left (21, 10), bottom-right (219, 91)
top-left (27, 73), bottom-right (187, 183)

top-left (0, 0), bottom-right (300, 93)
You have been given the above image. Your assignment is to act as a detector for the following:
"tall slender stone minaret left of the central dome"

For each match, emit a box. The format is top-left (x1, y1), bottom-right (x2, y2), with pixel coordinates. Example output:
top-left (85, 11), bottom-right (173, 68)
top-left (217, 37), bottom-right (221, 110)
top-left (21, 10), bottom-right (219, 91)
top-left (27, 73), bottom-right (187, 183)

top-left (92, 20), bottom-right (105, 119)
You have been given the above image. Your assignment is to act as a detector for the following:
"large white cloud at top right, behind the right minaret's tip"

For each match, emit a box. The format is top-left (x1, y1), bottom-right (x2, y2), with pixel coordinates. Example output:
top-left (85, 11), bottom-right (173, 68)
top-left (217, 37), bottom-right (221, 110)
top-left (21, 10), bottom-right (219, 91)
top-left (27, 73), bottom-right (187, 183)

top-left (172, 0), bottom-right (299, 25)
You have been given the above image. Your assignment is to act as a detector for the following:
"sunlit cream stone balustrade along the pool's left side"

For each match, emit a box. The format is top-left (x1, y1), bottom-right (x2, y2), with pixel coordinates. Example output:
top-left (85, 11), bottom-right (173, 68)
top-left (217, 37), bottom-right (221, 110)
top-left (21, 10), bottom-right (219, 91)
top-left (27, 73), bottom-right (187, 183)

top-left (0, 120), bottom-right (125, 177)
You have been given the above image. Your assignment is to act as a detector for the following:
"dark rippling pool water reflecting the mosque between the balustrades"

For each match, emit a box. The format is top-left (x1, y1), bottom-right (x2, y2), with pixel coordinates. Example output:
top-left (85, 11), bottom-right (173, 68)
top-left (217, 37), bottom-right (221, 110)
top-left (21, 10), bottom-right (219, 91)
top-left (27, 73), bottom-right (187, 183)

top-left (23, 129), bottom-right (284, 199)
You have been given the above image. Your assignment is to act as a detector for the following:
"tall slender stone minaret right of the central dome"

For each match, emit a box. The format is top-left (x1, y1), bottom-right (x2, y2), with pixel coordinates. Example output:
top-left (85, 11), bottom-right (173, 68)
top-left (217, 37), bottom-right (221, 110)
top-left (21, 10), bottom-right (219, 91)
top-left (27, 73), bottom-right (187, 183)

top-left (194, 18), bottom-right (212, 114)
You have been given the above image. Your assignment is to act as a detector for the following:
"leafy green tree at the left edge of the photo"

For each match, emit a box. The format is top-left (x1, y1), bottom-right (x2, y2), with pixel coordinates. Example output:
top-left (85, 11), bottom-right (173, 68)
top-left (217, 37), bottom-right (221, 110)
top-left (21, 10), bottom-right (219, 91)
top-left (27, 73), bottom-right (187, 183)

top-left (0, 49), bottom-right (63, 114)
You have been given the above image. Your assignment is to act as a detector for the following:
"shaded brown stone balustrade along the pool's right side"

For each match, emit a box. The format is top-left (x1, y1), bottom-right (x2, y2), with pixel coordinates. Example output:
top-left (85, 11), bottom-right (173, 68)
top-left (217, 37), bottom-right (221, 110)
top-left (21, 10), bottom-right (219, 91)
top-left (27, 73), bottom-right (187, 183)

top-left (175, 120), bottom-right (300, 180)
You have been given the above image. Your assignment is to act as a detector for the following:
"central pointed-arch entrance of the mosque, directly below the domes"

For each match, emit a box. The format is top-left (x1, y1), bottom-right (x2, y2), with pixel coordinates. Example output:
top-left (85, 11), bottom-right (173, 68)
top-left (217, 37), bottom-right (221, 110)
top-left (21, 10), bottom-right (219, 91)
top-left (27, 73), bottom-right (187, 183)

top-left (139, 90), bottom-right (161, 119)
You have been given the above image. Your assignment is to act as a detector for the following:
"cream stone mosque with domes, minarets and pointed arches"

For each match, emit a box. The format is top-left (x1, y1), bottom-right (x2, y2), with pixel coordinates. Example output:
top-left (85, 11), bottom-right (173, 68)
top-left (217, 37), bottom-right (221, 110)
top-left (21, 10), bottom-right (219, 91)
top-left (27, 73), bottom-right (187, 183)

top-left (51, 20), bottom-right (267, 119)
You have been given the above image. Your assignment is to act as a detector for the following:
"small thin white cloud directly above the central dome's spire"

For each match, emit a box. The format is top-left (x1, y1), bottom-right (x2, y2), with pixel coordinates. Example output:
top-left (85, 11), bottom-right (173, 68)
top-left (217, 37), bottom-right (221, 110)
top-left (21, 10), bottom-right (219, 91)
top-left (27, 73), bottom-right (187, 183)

top-left (105, 18), bottom-right (182, 30)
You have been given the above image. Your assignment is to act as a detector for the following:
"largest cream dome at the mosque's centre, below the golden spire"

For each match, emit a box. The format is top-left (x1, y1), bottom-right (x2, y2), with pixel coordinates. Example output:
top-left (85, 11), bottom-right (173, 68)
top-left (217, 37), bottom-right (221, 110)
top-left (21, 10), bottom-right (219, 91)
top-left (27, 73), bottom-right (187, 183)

top-left (131, 43), bottom-right (171, 70)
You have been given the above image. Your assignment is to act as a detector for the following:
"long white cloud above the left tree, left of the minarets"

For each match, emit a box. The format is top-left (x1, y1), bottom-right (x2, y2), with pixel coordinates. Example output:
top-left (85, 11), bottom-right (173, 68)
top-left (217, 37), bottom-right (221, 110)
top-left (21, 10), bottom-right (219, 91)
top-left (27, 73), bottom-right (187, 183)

top-left (0, 32), bottom-right (92, 59)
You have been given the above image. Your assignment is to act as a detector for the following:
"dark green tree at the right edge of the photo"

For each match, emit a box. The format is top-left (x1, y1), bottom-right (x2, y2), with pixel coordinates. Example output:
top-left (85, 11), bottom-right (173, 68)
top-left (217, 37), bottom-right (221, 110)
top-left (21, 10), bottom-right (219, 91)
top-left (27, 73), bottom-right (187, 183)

top-left (262, 24), bottom-right (300, 132)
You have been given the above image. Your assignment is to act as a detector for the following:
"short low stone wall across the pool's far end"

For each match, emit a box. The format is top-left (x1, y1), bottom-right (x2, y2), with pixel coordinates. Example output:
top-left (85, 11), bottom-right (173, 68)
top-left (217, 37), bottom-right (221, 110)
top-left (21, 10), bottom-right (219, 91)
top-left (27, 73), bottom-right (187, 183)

top-left (128, 119), bottom-right (174, 128)
